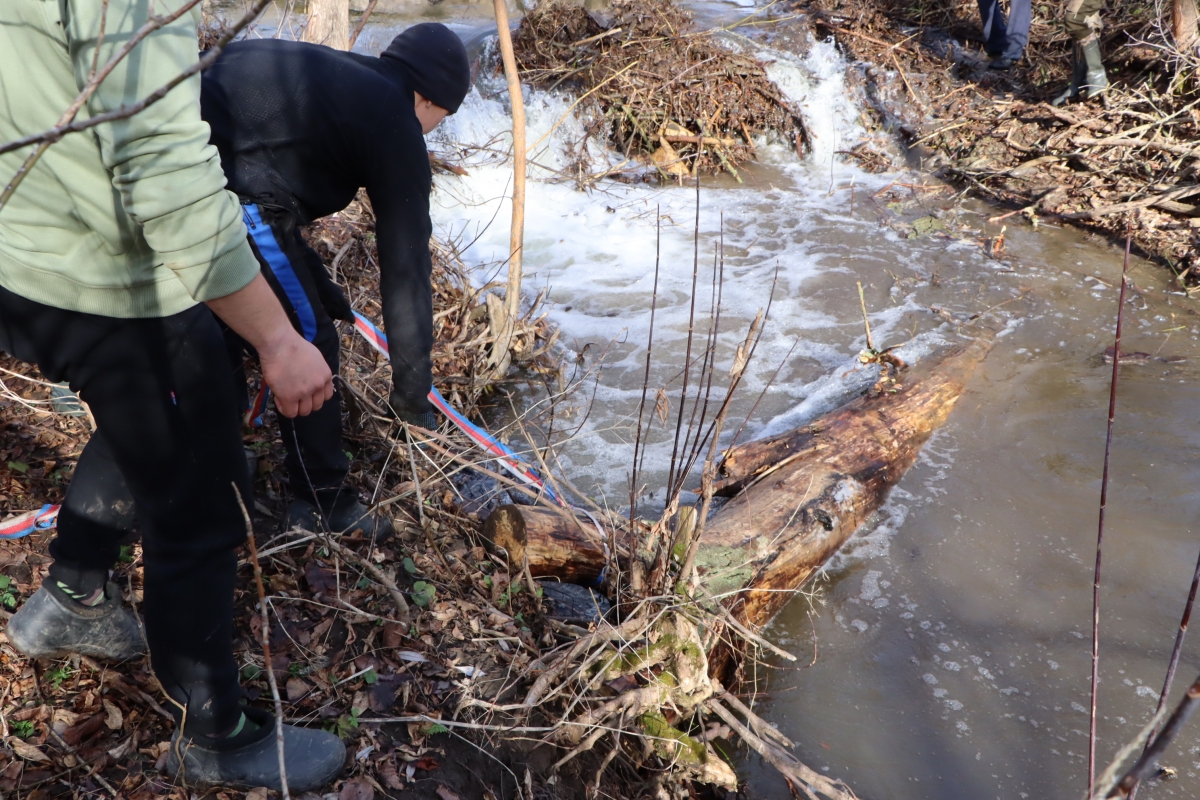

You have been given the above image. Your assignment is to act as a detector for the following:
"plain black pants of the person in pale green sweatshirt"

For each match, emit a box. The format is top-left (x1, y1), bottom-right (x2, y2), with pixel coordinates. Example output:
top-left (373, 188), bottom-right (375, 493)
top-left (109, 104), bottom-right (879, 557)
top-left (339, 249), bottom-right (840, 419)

top-left (0, 288), bottom-right (250, 734)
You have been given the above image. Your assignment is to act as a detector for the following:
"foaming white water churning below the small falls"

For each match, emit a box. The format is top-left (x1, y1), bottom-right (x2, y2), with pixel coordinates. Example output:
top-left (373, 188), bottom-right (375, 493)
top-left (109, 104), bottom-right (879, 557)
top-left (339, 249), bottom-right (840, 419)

top-left (431, 34), bottom-right (950, 503)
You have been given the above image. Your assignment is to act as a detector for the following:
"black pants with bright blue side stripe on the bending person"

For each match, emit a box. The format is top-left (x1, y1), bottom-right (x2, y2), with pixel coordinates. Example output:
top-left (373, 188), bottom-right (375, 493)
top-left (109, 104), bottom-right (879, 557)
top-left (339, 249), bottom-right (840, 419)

top-left (226, 203), bottom-right (354, 511)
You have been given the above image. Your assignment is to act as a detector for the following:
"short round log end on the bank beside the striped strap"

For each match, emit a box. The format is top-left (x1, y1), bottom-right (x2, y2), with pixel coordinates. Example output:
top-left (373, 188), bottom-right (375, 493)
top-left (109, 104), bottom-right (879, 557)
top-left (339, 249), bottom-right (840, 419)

top-left (484, 505), bottom-right (608, 585)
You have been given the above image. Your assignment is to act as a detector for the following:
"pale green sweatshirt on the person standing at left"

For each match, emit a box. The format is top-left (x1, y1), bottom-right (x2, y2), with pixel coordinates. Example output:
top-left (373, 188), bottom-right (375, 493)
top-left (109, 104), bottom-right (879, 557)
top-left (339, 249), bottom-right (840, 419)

top-left (0, 0), bottom-right (259, 318)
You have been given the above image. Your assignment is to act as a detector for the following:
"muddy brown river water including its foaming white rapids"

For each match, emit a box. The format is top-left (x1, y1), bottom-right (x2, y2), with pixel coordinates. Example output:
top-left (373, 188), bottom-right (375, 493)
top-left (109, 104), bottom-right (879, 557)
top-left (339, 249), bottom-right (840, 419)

top-left (220, 0), bottom-right (1200, 800)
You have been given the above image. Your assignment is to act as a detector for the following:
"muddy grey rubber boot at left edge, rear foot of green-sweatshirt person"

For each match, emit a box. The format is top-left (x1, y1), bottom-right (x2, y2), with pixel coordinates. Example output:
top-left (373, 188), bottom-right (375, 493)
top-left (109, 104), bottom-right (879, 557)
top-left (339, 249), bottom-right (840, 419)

top-left (5, 582), bottom-right (146, 661)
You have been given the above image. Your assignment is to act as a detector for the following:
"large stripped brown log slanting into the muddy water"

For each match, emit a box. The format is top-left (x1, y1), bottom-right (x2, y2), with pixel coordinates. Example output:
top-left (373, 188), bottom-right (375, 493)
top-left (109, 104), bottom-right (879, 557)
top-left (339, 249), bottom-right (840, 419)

top-left (696, 338), bottom-right (991, 675)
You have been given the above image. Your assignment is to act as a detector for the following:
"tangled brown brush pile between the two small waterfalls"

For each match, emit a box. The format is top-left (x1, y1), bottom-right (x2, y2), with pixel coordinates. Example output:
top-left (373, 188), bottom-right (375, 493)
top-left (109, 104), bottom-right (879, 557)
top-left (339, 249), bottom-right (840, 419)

top-left (512, 0), bottom-right (806, 178)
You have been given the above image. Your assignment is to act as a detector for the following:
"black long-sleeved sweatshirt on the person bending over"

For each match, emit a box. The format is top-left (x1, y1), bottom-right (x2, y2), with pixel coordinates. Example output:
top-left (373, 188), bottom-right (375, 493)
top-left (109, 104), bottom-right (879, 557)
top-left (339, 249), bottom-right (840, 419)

top-left (200, 40), bottom-right (433, 414)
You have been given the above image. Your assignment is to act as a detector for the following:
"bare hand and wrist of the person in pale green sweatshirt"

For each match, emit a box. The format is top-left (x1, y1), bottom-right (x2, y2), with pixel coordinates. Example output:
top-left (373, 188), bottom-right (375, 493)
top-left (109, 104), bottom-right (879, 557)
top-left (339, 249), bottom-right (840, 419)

top-left (208, 275), bottom-right (334, 416)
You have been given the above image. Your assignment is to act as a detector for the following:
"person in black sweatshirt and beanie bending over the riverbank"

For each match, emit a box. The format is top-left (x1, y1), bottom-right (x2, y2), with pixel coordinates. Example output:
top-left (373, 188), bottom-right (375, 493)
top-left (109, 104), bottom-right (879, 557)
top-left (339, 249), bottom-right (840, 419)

top-left (200, 23), bottom-right (470, 540)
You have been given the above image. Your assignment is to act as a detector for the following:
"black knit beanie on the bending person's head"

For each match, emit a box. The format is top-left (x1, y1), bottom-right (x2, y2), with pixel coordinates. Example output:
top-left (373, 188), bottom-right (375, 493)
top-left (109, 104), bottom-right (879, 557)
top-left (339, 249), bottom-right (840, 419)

top-left (379, 23), bottom-right (470, 114)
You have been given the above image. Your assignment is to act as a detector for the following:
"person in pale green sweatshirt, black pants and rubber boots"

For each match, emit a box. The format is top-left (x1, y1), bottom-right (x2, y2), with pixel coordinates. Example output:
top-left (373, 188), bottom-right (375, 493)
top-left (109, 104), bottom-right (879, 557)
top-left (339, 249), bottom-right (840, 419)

top-left (0, 0), bottom-right (344, 790)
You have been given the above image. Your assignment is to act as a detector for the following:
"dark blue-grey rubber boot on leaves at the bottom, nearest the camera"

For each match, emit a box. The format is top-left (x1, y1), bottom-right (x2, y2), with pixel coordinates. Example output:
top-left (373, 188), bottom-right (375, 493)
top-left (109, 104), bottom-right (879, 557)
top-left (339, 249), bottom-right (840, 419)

top-left (167, 708), bottom-right (346, 792)
